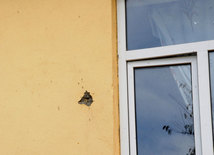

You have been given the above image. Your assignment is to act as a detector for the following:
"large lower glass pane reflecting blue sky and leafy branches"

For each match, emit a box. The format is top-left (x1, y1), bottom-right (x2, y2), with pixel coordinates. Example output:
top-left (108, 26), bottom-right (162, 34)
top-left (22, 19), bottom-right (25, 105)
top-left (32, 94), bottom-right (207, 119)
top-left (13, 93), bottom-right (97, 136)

top-left (134, 65), bottom-right (195, 155)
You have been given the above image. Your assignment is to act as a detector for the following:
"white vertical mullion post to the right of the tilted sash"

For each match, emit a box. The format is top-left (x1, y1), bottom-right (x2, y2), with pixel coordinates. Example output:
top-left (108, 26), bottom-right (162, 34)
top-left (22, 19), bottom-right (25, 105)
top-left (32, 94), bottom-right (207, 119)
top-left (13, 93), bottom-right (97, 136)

top-left (197, 50), bottom-right (213, 155)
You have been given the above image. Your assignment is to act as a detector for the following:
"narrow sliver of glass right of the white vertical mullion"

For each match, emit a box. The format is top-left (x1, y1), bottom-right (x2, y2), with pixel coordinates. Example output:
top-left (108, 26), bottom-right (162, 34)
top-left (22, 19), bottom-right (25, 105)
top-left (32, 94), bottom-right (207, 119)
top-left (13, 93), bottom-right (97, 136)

top-left (209, 52), bottom-right (214, 137)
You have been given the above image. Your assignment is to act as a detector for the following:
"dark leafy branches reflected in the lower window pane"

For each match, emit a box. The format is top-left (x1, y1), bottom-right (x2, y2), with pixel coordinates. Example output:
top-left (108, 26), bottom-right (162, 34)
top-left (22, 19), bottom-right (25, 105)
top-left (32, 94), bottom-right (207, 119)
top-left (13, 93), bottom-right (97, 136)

top-left (162, 84), bottom-right (195, 155)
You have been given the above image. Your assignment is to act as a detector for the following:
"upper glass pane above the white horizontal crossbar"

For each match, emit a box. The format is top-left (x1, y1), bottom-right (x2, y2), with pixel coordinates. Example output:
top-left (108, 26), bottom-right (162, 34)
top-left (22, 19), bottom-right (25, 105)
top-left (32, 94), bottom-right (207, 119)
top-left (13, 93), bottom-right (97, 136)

top-left (126, 0), bottom-right (214, 50)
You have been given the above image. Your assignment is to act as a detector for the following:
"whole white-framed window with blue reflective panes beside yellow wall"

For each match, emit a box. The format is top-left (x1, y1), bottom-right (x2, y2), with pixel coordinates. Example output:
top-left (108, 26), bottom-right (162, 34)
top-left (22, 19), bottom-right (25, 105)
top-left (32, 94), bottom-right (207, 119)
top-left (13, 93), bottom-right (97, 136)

top-left (117, 0), bottom-right (214, 155)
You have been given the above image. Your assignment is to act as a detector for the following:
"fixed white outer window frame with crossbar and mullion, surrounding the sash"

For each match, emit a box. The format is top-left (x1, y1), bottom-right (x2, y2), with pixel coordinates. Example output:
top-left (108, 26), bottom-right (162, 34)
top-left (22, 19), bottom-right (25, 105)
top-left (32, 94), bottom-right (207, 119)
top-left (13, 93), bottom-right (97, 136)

top-left (117, 0), bottom-right (214, 155)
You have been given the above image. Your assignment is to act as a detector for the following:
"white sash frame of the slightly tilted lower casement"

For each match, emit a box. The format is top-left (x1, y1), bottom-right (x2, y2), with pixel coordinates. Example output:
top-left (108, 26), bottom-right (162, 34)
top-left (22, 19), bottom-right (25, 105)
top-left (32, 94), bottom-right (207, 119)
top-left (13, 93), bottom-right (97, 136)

top-left (128, 56), bottom-right (201, 155)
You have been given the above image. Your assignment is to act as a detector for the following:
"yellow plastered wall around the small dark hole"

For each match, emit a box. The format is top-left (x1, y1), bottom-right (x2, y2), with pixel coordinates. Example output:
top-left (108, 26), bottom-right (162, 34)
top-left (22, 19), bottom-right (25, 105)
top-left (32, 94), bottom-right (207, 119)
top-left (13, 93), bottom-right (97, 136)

top-left (0, 0), bottom-right (119, 155)
